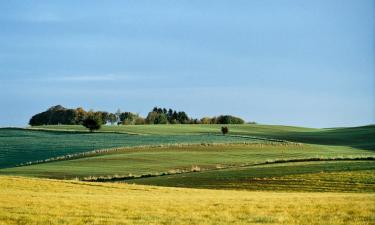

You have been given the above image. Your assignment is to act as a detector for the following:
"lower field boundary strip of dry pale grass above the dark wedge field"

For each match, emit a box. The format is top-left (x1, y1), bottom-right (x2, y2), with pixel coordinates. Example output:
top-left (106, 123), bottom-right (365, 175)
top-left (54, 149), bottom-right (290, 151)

top-left (81, 156), bottom-right (375, 182)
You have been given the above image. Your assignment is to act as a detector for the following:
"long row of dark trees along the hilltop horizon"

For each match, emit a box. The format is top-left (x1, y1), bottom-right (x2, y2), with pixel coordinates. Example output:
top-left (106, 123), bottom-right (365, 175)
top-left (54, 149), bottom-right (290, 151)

top-left (29, 105), bottom-right (245, 126)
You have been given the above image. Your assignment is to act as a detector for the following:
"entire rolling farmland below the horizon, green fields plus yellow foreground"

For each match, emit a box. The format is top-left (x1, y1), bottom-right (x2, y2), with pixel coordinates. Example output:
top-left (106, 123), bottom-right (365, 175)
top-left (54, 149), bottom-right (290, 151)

top-left (0, 124), bottom-right (375, 224)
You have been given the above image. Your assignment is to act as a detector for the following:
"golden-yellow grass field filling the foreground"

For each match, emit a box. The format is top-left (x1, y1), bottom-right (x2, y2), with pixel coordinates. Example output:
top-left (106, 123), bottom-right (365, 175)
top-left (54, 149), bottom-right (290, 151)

top-left (0, 176), bottom-right (375, 225)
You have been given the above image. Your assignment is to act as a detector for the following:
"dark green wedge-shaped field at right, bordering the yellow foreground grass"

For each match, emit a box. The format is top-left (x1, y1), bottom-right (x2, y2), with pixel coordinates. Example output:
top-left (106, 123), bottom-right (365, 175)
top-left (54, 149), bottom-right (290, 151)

top-left (124, 161), bottom-right (375, 192)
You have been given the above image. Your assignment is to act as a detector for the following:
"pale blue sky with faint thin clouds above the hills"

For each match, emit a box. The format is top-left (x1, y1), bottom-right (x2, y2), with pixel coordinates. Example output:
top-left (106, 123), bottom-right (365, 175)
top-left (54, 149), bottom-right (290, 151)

top-left (0, 0), bottom-right (375, 127)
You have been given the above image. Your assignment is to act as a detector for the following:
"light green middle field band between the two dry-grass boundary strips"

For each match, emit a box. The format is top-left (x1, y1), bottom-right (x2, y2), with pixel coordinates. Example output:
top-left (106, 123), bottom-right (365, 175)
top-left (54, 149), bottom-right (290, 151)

top-left (0, 144), bottom-right (375, 178)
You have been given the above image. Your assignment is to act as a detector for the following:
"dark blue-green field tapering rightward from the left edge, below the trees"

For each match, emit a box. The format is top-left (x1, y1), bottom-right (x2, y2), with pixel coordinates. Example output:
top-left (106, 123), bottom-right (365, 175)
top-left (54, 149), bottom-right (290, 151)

top-left (0, 129), bottom-right (262, 168)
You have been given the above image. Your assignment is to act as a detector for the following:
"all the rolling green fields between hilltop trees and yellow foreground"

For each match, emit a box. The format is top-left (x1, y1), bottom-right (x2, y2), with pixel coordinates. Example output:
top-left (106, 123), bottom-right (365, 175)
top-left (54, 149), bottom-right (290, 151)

top-left (0, 124), bottom-right (375, 192)
